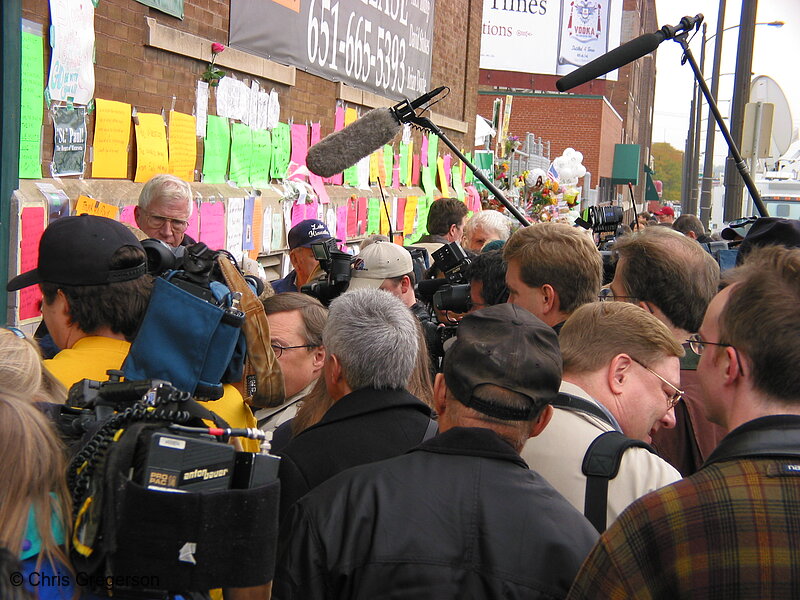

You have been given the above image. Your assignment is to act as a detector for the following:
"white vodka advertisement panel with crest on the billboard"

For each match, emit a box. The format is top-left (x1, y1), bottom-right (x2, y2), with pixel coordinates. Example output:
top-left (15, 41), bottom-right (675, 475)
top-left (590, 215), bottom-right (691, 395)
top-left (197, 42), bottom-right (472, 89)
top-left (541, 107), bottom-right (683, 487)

top-left (556, 0), bottom-right (610, 75)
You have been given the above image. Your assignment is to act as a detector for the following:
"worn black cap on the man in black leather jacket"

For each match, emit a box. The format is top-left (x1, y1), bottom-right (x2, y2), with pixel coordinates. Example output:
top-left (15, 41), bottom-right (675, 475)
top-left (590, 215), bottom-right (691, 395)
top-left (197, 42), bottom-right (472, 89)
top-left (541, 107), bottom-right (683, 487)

top-left (442, 304), bottom-right (561, 421)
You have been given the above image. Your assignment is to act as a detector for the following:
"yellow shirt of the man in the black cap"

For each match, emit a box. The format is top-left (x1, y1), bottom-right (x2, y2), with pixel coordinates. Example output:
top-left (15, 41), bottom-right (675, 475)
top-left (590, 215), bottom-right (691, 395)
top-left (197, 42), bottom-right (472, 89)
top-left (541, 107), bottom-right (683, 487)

top-left (44, 335), bottom-right (259, 452)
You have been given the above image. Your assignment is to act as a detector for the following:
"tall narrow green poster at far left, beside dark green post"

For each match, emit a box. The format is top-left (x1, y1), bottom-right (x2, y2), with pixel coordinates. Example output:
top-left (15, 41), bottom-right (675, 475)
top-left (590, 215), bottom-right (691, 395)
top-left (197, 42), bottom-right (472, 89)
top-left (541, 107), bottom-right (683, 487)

top-left (19, 31), bottom-right (44, 179)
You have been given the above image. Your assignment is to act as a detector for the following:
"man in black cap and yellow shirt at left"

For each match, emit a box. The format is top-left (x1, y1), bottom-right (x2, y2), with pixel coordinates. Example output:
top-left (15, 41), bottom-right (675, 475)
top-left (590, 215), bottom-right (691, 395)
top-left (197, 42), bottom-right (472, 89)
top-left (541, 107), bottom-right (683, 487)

top-left (6, 215), bottom-right (257, 446)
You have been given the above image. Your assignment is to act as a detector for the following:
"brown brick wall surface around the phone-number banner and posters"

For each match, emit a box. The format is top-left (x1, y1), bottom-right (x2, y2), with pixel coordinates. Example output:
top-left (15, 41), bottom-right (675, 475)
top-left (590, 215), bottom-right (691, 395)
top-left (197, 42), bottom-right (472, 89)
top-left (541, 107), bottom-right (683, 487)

top-left (22, 0), bottom-right (482, 178)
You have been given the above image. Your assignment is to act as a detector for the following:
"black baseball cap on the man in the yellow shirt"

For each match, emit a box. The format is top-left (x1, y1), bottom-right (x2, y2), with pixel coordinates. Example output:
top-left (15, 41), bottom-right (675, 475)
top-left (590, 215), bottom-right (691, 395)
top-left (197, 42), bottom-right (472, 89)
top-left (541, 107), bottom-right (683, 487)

top-left (6, 215), bottom-right (147, 292)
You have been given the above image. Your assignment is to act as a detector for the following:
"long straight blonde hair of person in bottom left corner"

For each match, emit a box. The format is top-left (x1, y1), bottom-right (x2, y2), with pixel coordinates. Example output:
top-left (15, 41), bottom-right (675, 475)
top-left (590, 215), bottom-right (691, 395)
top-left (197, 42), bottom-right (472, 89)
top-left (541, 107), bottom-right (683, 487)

top-left (0, 392), bottom-right (71, 570)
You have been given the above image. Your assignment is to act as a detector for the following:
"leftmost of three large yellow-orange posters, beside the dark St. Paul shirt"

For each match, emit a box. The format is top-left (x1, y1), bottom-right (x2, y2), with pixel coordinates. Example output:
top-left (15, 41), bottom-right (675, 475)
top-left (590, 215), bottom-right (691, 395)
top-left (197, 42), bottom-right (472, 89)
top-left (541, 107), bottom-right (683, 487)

top-left (92, 98), bottom-right (131, 179)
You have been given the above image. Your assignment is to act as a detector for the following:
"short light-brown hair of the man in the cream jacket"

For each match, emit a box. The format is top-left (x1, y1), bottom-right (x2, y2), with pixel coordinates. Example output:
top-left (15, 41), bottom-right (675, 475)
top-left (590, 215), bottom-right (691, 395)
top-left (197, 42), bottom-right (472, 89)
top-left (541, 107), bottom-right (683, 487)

top-left (558, 302), bottom-right (684, 373)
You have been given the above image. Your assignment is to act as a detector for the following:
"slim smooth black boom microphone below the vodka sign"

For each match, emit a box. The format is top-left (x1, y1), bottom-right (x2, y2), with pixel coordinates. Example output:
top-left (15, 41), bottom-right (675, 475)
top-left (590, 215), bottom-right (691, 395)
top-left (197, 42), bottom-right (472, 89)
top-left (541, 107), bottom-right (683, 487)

top-left (556, 15), bottom-right (703, 92)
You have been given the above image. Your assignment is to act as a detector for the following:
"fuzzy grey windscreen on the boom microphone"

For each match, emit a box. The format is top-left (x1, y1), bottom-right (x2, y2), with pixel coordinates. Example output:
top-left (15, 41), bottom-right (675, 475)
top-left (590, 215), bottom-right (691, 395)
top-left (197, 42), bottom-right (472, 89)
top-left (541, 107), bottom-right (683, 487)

top-left (306, 108), bottom-right (400, 177)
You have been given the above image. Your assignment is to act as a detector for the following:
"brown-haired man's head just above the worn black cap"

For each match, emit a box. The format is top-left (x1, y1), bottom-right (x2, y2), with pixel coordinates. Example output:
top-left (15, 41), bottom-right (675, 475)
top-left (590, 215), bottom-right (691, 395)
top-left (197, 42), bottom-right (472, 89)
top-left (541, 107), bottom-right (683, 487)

top-left (503, 223), bottom-right (603, 333)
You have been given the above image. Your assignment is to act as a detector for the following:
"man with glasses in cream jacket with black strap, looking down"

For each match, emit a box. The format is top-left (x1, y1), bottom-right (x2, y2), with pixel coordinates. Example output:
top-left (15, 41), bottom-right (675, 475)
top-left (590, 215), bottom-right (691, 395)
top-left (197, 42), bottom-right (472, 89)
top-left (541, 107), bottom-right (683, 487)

top-left (522, 302), bottom-right (683, 532)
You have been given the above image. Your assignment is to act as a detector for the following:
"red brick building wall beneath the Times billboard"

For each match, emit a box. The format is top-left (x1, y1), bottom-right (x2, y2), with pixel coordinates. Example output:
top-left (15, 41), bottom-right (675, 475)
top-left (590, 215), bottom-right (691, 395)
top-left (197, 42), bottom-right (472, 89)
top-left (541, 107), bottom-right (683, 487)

top-left (478, 92), bottom-right (622, 179)
